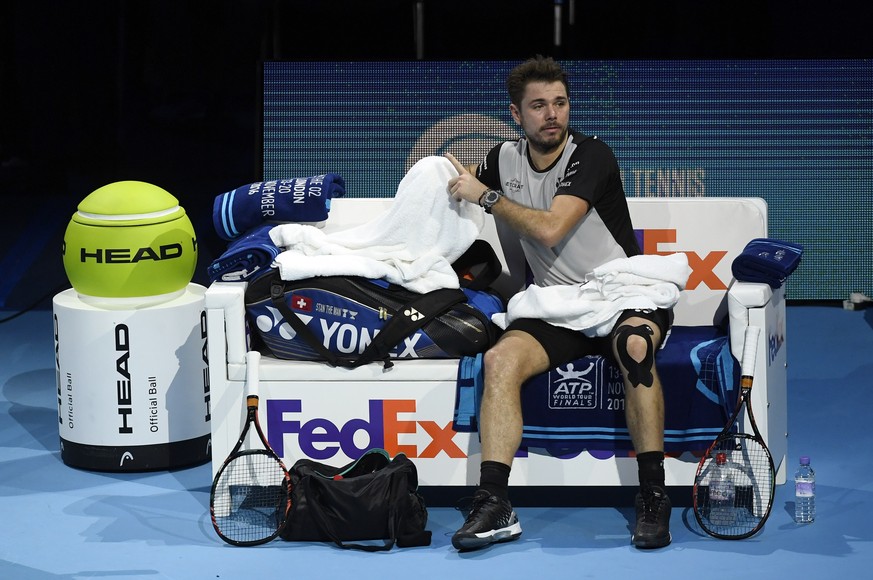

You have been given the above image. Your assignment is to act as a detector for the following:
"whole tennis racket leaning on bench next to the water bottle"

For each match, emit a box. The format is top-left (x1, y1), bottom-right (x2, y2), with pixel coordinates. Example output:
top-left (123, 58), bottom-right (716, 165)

top-left (694, 326), bottom-right (776, 540)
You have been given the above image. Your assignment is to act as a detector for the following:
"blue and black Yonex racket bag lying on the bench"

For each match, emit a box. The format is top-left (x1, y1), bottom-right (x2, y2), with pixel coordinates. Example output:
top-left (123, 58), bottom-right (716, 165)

top-left (245, 239), bottom-right (505, 368)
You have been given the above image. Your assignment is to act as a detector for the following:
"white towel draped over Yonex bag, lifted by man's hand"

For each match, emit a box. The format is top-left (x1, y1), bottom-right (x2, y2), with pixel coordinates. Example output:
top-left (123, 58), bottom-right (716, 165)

top-left (270, 156), bottom-right (485, 293)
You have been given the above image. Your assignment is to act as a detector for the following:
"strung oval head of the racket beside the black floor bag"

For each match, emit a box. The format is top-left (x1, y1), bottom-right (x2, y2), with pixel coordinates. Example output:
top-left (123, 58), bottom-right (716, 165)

top-left (212, 452), bottom-right (287, 543)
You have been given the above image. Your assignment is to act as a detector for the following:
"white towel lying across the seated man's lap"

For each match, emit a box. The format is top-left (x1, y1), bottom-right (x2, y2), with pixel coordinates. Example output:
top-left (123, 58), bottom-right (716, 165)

top-left (491, 252), bottom-right (691, 337)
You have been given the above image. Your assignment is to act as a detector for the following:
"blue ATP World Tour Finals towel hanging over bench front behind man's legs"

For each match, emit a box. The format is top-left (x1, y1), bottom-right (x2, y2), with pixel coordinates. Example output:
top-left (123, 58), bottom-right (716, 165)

top-left (452, 326), bottom-right (740, 454)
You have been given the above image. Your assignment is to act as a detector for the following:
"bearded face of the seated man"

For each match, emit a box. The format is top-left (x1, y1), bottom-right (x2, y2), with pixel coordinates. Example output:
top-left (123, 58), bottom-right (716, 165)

top-left (509, 81), bottom-right (570, 153)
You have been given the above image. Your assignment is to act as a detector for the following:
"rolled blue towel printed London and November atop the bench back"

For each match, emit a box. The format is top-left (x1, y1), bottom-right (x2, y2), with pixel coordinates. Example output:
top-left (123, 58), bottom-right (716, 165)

top-left (212, 173), bottom-right (346, 241)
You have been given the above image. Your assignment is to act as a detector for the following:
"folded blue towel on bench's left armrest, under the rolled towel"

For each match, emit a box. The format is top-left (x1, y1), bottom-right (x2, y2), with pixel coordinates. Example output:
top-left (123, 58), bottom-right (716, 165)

top-left (207, 224), bottom-right (281, 282)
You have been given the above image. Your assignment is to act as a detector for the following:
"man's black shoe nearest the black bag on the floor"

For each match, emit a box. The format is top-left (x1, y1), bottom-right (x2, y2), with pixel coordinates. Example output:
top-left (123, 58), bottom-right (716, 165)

top-left (452, 489), bottom-right (521, 551)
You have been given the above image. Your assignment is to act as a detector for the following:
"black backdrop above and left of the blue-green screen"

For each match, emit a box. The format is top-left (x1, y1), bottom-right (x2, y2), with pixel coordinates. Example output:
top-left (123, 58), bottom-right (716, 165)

top-left (0, 0), bottom-right (873, 308)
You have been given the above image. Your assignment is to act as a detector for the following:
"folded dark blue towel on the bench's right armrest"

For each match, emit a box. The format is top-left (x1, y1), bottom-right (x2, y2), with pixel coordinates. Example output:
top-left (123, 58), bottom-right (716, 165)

top-left (731, 238), bottom-right (803, 288)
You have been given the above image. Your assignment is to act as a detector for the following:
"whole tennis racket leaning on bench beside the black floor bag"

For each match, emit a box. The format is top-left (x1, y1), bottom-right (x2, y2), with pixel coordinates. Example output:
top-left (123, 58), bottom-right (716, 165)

top-left (209, 351), bottom-right (291, 546)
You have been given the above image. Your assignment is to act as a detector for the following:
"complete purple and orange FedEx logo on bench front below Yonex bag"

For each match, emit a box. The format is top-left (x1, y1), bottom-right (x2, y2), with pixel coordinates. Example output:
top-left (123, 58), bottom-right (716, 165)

top-left (267, 399), bottom-right (466, 461)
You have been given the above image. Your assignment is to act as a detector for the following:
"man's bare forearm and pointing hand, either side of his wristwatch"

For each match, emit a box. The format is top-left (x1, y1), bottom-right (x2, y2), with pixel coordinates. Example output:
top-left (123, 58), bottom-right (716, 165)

top-left (446, 153), bottom-right (588, 248)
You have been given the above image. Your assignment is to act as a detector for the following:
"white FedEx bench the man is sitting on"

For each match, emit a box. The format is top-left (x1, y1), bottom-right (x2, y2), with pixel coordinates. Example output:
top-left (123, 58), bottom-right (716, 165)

top-left (206, 198), bottom-right (787, 500)
